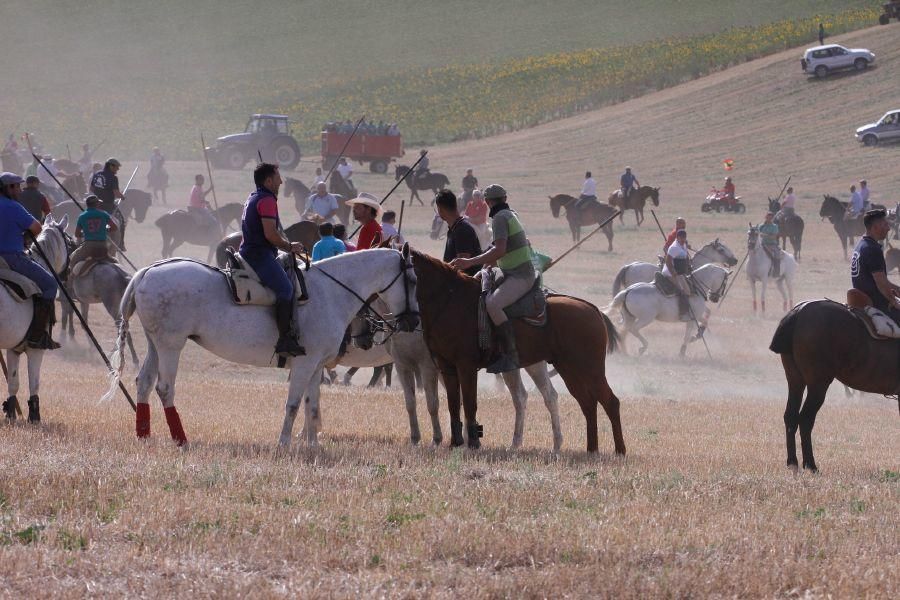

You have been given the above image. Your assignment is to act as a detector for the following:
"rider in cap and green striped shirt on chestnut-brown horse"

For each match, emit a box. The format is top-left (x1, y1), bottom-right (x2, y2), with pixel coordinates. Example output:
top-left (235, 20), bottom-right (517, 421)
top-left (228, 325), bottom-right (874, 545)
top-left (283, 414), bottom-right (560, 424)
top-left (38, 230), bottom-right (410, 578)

top-left (450, 184), bottom-right (536, 373)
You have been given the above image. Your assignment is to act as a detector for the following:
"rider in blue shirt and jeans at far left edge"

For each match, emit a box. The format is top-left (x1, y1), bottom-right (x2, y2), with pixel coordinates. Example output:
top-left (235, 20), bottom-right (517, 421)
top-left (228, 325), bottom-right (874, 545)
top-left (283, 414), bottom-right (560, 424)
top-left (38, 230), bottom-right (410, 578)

top-left (0, 173), bottom-right (59, 350)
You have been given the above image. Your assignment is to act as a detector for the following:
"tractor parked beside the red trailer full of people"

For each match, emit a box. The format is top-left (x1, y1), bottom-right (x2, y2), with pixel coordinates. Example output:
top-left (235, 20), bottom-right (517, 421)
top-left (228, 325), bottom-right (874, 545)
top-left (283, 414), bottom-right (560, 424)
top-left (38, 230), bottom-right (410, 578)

top-left (206, 114), bottom-right (300, 169)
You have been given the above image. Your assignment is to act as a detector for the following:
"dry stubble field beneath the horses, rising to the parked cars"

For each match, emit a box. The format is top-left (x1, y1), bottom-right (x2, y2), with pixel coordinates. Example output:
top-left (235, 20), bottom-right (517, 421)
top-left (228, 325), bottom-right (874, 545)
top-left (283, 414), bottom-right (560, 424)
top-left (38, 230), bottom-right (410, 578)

top-left (0, 28), bottom-right (900, 598)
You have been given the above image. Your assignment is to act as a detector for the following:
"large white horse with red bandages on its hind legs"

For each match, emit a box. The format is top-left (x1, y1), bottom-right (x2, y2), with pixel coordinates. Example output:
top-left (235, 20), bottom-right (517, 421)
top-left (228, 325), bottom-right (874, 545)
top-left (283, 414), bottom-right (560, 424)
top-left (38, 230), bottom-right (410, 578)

top-left (104, 246), bottom-right (418, 446)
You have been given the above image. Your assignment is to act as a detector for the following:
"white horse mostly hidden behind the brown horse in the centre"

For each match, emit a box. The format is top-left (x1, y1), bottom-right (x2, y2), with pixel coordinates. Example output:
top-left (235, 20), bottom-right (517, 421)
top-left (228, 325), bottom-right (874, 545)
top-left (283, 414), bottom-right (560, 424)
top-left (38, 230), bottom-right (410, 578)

top-left (324, 301), bottom-right (562, 452)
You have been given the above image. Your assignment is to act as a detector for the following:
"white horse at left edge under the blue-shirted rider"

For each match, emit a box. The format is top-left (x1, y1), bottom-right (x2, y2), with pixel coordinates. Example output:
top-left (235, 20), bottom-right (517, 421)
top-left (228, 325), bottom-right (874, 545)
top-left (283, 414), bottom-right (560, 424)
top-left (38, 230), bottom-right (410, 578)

top-left (0, 215), bottom-right (69, 422)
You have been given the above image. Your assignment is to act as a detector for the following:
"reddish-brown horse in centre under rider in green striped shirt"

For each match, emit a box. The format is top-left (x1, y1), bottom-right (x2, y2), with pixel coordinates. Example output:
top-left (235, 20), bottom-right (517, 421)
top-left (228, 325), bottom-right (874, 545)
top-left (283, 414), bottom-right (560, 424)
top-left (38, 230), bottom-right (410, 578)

top-left (412, 252), bottom-right (625, 454)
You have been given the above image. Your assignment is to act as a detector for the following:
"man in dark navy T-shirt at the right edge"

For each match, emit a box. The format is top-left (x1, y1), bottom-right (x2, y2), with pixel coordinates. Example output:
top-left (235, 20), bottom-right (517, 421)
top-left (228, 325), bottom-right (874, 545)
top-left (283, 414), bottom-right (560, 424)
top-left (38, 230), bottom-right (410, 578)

top-left (850, 209), bottom-right (900, 323)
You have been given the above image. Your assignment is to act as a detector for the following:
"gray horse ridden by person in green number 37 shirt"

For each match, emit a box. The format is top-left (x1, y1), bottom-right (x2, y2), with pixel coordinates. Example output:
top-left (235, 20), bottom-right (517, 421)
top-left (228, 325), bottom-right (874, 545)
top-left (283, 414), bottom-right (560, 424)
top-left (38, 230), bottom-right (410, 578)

top-left (60, 262), bottom-right (138, 365)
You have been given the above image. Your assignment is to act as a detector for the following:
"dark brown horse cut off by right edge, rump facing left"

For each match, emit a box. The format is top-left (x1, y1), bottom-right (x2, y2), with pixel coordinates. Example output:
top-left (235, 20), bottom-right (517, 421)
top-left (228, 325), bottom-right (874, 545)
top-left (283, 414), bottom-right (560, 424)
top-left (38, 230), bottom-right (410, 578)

top-left (769, 300), bottom-right (900, 471)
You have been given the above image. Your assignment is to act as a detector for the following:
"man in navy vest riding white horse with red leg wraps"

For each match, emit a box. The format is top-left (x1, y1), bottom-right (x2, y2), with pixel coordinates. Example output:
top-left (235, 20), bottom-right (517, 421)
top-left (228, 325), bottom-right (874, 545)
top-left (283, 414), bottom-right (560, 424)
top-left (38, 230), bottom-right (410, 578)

top-left (240, 163), bottom-right (306, 357)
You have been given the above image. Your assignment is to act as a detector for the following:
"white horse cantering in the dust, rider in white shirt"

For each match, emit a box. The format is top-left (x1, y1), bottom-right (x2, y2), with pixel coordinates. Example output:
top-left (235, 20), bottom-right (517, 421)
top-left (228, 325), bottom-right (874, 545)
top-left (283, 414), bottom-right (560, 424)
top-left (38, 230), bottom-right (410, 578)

top-left (603, 264), bottom-right (731, 356)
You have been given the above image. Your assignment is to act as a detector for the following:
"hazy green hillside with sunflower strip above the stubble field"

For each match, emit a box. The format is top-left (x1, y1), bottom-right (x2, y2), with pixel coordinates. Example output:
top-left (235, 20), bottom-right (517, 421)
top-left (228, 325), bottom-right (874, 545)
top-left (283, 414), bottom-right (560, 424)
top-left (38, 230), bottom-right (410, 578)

top-left (0, 0), bottom-right (877, 158)
